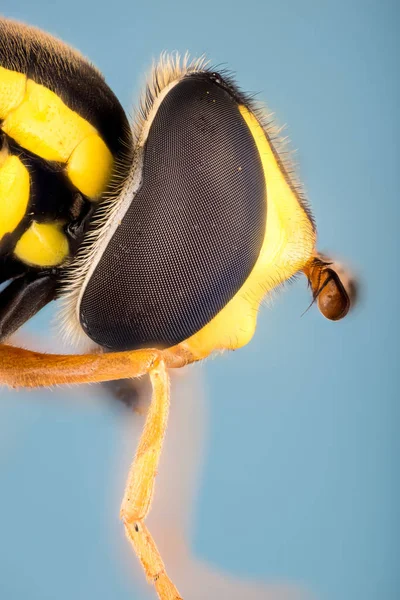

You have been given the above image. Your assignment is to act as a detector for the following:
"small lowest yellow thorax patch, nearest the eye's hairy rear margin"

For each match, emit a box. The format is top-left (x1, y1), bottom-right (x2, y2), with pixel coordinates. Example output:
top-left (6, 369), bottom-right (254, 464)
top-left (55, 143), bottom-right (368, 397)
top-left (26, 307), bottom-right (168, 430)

top-left (15, 221), bottom-right (69, 267)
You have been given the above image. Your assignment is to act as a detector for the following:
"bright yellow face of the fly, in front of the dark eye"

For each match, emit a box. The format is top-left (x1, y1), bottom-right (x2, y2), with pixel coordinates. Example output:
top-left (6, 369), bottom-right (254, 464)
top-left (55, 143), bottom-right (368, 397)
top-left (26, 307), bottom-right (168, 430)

top-left (181, 106), bottom-right (315, 358)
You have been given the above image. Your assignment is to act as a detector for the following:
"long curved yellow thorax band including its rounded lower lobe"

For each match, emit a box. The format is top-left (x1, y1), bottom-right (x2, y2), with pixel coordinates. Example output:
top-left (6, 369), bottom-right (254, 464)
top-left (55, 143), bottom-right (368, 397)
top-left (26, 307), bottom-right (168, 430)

top-left (0, 67), bottom-right (113, 200)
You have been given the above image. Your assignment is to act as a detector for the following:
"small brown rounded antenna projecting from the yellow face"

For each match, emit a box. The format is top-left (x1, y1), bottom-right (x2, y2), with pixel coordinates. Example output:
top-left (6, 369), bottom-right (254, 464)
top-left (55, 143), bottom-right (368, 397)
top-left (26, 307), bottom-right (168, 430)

top-left (306, 255), bottom-right (357, 321)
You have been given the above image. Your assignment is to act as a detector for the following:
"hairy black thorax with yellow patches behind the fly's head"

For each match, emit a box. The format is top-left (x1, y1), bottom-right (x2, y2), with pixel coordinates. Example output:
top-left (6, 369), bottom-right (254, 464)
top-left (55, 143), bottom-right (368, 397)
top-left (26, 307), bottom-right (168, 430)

top-left (0, 20), bottom-right (129, 272)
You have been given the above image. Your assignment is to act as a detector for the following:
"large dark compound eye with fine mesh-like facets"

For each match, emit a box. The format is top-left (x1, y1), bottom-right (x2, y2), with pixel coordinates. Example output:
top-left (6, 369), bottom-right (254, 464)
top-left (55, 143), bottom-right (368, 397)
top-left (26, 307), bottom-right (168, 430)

top-left (79, 74), bottom-right (267, 350)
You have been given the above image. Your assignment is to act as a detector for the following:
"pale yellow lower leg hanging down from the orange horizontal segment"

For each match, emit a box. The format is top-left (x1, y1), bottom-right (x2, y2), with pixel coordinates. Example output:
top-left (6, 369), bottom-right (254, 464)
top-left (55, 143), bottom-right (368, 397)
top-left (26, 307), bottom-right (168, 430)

top-left (121, 361), bottom-right (182, 600)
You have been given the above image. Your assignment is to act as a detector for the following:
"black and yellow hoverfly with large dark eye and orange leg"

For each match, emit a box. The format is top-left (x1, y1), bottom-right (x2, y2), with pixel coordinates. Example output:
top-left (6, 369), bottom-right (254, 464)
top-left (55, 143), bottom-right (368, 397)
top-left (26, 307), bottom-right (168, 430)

top-left (0, 19), bottom-right (354, 600)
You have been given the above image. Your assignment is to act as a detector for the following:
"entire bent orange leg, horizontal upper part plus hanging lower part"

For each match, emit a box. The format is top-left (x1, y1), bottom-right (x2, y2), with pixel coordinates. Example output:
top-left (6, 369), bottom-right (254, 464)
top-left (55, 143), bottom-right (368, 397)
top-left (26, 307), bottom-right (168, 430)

top-left (0, 344), bottom-right (196, 600)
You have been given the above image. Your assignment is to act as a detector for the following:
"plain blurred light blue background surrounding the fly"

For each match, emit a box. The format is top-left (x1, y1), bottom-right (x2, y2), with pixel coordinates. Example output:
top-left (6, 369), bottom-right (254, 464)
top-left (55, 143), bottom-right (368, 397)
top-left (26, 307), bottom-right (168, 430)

top-left (0, 0), bottom-right (400, 600)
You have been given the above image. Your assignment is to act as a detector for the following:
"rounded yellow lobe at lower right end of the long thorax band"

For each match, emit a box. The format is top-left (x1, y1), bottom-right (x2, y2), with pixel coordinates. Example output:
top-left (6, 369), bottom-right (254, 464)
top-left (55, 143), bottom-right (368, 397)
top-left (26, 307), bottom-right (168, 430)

top-left (67, 135), bottom-right (113, 200)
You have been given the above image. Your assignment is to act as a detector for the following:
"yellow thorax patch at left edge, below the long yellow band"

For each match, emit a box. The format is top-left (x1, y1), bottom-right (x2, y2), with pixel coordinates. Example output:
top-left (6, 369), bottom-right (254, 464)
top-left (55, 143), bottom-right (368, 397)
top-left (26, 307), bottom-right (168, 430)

top-left (0, 154), bottom-right (29, 240)
